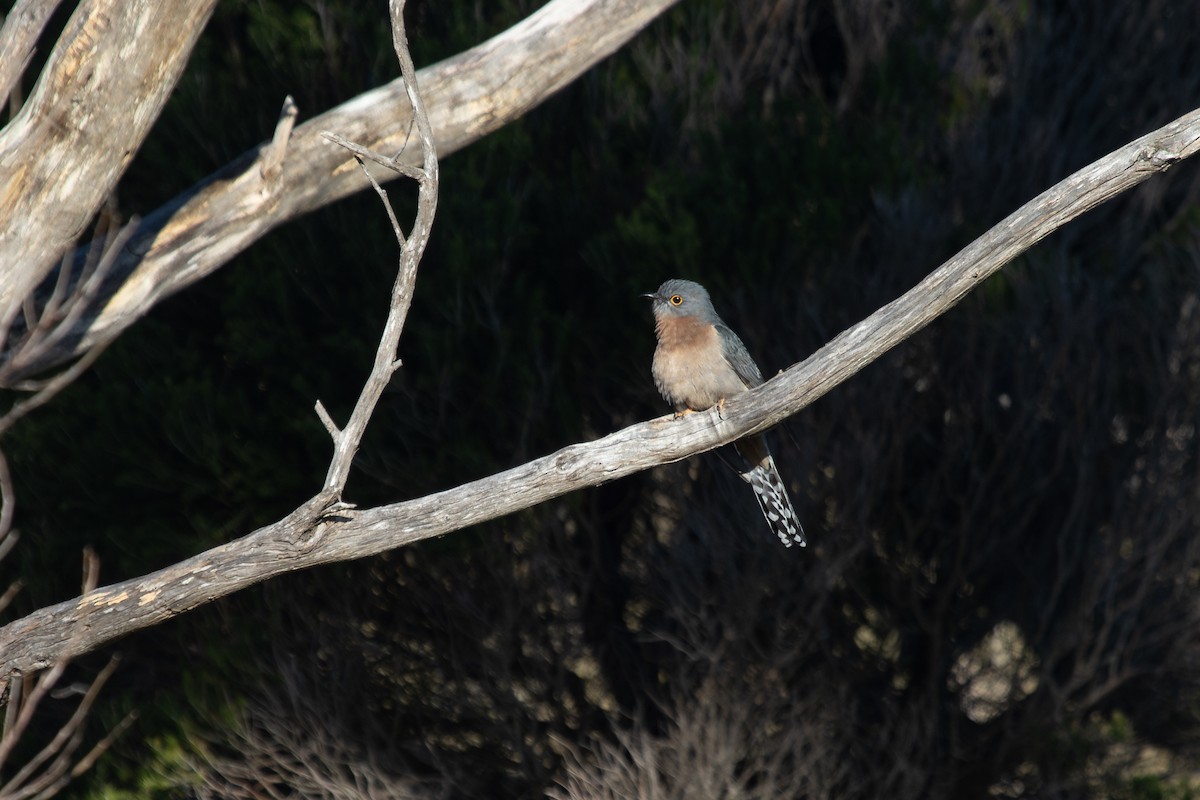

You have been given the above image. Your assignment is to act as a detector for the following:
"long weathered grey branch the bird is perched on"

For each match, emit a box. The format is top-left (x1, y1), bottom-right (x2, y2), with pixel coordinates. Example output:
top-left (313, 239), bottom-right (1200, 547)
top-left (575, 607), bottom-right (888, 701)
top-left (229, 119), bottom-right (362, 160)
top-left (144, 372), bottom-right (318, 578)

top-left (0, 104), bottom-right (1200, 681)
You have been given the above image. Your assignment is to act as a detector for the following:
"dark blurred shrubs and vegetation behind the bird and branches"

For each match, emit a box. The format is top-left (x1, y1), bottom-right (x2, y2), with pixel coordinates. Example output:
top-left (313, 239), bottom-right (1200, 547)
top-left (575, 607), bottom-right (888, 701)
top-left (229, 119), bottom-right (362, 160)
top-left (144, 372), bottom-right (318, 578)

top-left (4, 0), bottom-right (1200, 800)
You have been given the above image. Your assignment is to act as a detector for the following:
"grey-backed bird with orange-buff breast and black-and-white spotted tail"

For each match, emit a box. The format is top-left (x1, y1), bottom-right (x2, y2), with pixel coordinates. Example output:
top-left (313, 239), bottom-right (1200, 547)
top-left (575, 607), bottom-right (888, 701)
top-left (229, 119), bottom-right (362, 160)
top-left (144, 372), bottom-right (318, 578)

top-left (642, 278), bottom-right (808, 547)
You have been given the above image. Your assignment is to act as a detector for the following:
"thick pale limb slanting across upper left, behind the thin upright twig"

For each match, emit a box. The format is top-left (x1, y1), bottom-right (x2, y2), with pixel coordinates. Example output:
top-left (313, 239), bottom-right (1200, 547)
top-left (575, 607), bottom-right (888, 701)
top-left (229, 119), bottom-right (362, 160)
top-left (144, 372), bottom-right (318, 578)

top-left (0, 0), bottom-right (676, 386)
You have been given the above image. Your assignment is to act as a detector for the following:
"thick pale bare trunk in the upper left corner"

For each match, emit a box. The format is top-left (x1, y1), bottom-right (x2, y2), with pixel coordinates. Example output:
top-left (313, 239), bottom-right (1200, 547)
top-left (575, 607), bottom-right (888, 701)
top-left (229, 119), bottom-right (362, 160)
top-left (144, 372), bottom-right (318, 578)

top-left (0, 0), bottom-right (216, 327)
